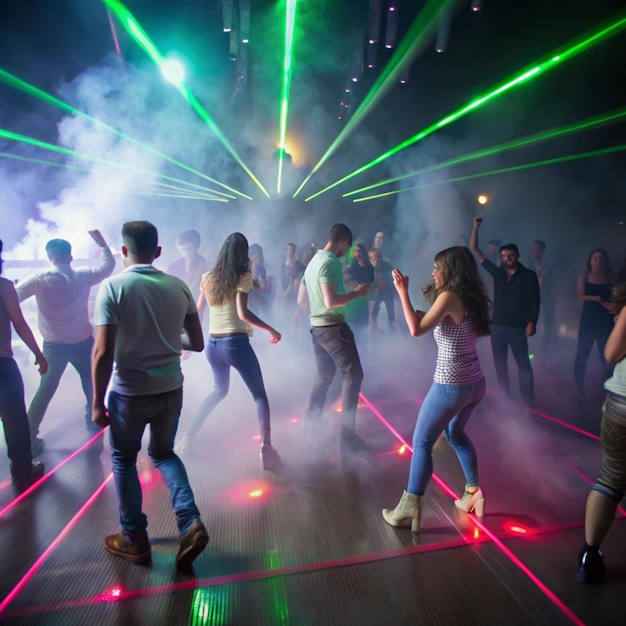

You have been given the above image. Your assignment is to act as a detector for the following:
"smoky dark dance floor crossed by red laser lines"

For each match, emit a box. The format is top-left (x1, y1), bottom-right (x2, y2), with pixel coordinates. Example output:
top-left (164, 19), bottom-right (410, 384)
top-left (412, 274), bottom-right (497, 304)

top-left (0, 333), bottom-right (626, 626)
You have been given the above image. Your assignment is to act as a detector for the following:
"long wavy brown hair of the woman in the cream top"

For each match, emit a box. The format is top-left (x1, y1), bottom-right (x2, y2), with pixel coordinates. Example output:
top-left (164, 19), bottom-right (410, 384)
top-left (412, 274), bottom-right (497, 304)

top-left (200, 233), bottom-right (250, 306)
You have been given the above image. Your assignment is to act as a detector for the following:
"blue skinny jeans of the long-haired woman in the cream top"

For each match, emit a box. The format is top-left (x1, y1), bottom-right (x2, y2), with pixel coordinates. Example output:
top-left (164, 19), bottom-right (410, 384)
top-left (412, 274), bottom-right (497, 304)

top-left (189, 335), bottom-right (271, 444)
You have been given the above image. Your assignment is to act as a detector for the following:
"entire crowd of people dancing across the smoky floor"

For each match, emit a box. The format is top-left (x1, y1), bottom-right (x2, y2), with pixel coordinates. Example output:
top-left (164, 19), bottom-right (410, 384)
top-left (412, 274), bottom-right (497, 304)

top-left (0, 217), bottom-right (626, 583)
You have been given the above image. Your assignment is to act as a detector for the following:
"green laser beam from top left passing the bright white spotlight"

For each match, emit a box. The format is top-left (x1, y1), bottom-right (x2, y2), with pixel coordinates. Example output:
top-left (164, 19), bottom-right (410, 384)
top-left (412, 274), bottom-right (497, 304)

top-left (102, 0), bottom-right (270, 198)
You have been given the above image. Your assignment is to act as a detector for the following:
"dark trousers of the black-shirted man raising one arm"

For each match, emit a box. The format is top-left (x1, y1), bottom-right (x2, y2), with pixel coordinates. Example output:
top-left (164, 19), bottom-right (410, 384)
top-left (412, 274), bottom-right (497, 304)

top-left (491, 325), bottom-right (535, 407)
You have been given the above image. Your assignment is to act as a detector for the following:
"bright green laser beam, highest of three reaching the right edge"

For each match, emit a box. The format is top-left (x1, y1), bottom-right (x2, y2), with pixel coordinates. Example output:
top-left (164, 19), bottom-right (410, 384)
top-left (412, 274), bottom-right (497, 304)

top-left (306, 11), bottom-right (626, 202)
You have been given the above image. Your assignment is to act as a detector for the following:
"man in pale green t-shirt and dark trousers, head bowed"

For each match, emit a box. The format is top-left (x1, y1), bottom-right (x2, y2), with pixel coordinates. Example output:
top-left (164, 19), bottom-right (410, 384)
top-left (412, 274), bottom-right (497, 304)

top-left (298, 224), bottom-right (370, 453)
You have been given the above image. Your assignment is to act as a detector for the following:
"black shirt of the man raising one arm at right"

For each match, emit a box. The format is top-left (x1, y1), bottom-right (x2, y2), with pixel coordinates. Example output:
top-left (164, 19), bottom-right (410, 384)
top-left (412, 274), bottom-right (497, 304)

top-left (482, 259), bottom-right (539, 327)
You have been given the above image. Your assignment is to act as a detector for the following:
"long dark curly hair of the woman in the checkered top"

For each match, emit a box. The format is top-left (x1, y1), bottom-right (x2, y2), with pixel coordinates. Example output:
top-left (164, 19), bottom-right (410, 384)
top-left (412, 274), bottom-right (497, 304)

top-left (422, 246), bottom-right (491, 336)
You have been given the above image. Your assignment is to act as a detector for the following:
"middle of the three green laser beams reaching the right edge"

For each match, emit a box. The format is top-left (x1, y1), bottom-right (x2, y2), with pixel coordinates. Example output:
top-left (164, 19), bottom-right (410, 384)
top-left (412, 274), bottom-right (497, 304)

top-left (343, 107), bottom-right (626, 198)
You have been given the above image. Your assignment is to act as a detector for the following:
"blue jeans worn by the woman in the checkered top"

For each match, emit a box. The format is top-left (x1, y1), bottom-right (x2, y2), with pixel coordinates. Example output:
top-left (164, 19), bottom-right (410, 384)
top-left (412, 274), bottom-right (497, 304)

top-left (407, 378), bottom-right (485, 496)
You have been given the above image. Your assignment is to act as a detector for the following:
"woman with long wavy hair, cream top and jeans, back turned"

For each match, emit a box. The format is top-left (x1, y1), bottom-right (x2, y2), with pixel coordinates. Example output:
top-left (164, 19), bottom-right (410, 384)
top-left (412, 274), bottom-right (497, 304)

top-left (176, 233), bottom-right (281, 470)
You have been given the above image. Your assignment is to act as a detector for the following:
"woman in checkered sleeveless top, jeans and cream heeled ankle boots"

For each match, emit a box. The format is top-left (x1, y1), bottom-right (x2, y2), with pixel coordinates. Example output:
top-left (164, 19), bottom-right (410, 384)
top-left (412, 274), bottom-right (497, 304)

top-left (383, 246), bottom-right (491, 533)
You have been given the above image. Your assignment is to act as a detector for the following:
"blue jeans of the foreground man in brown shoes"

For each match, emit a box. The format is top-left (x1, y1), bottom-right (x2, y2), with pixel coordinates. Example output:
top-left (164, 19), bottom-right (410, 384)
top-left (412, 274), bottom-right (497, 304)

top-left (109, 389), bottom-right (200, 534)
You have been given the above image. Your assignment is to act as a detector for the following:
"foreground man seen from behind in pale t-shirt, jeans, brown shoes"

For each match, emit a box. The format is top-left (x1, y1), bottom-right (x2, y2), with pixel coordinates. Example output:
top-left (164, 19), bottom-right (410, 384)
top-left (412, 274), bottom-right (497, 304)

top-left (92, 222), bottom-right (209, 570)
